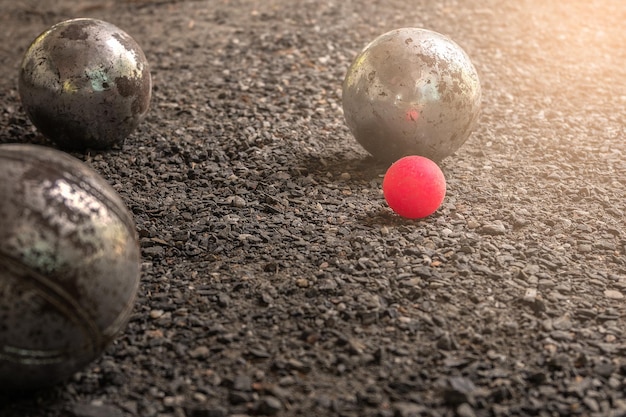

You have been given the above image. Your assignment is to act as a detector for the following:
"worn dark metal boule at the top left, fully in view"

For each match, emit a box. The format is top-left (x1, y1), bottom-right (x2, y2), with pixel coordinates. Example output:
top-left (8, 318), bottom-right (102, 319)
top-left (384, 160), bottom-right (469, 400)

top-left (19, 18), bottom-right (152, 149)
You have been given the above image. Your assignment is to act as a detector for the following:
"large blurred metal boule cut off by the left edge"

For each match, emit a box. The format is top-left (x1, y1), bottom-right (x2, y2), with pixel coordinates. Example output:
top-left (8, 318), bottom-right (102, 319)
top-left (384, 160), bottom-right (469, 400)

top-left (0, 144), bottom-right (140, 389)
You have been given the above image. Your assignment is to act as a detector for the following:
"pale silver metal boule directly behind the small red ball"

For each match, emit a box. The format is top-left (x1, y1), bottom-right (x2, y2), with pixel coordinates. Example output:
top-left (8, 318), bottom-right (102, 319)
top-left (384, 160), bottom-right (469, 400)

top-left (342, 28), bottom-right (481, 162)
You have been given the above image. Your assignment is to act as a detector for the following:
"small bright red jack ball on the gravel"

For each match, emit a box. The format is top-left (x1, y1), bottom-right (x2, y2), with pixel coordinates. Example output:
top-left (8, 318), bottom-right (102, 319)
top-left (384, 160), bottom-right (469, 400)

top-left (383, 155), bottom-right (446, 219)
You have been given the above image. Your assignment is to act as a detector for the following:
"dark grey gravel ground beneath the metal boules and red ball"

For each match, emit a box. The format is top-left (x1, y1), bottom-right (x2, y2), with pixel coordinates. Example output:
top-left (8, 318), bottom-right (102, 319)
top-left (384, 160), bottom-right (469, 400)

top-left (0, 0), bottom-right (626, 417)
